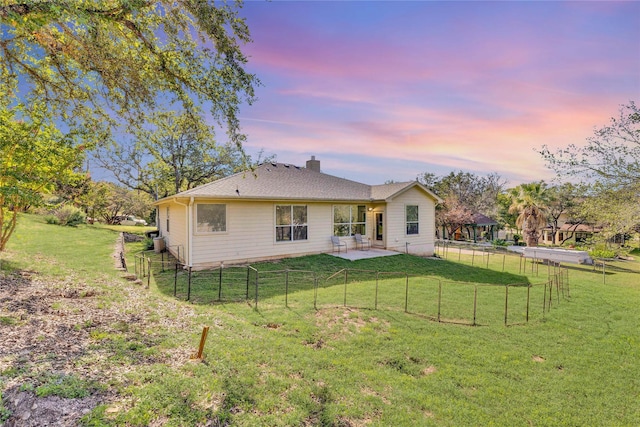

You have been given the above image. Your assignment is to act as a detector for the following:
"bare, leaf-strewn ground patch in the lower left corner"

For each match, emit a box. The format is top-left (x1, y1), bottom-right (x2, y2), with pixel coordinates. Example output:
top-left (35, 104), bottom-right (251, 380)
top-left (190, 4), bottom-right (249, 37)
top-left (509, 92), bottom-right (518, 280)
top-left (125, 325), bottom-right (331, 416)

top-left (0, 242), bottom-right (193, 427)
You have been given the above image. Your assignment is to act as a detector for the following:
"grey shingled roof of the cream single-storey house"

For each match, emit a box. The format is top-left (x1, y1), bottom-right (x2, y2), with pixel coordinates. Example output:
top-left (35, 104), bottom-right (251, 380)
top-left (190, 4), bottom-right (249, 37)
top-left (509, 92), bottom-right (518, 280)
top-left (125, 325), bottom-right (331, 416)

top-left (156, 163), bottom-right (440, 204)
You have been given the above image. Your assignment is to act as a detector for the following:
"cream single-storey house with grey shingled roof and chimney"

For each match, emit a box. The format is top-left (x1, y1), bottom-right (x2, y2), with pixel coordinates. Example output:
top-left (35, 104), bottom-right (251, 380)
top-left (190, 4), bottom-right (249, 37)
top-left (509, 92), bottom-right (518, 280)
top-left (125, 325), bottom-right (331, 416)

top-left (155, 157), bottom-right (441, 268)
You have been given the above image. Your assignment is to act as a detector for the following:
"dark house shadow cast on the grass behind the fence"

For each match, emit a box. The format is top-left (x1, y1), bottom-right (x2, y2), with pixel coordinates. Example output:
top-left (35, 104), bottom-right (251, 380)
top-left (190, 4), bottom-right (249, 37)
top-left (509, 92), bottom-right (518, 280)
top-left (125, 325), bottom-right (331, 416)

top-left (152, 254), bottom-right (528, 305)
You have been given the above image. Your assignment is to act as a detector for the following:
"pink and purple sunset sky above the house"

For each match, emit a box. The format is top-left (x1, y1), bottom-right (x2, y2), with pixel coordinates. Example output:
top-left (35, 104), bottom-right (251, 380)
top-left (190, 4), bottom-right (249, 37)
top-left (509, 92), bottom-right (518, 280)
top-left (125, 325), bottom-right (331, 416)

top-left (235, 1), bottom-right (640, 185)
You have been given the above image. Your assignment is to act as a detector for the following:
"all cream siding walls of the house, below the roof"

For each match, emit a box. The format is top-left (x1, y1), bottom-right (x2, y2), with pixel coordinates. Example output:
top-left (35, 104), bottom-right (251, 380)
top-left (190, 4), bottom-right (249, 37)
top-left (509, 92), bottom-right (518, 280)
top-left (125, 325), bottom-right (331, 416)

top-left (158, 188), bottom-right (435, 268)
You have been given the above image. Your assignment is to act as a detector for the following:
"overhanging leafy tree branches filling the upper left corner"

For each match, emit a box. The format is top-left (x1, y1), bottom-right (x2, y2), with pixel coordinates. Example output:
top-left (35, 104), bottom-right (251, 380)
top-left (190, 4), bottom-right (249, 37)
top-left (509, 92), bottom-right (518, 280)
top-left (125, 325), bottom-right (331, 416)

top-left (0, 0), bottom-right (259, 152)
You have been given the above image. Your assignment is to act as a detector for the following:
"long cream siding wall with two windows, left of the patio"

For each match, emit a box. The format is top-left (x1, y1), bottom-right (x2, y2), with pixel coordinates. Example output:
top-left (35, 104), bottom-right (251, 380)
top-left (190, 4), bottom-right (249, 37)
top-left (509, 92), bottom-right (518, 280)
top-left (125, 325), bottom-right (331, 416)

top-left (189, 200), bottom-right (336, 268)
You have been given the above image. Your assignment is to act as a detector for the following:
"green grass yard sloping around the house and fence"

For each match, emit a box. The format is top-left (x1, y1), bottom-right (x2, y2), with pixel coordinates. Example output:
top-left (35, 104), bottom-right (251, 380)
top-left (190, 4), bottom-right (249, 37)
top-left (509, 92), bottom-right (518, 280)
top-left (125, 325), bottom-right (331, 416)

top-left (0, 216), bottom-right (640, 426)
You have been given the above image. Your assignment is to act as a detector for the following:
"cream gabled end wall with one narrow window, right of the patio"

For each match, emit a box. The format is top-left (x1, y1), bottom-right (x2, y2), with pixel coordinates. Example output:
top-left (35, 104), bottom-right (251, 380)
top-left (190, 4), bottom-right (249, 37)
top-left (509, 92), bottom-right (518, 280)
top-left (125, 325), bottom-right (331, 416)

top-left (385, 187), bottom-right (435, 256)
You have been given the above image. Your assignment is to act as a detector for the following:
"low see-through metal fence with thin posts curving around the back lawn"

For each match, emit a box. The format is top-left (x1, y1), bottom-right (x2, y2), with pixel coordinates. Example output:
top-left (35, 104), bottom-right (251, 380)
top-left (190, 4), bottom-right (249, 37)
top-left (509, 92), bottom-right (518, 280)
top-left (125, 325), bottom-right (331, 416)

top-left (134, 251), bottom-right (570, 325)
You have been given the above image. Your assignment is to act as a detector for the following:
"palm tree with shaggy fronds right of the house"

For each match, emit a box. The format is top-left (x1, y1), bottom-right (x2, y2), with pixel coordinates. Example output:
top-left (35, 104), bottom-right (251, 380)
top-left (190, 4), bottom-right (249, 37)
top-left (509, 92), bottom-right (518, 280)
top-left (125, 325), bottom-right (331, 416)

top-left (509, 181), bottom-right (548, 246)
